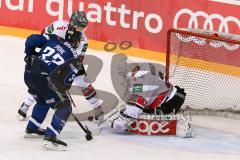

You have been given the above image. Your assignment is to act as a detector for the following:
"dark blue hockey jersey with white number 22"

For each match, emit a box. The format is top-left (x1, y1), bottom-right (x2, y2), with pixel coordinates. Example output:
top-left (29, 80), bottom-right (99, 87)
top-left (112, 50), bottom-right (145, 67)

top-left (25, 34), bottom-right (78, 83)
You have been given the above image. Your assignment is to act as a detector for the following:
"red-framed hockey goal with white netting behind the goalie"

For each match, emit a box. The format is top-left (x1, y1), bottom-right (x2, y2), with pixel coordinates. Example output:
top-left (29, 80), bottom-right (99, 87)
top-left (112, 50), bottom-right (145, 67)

top-left (166, 29), bottom-right (240, 118)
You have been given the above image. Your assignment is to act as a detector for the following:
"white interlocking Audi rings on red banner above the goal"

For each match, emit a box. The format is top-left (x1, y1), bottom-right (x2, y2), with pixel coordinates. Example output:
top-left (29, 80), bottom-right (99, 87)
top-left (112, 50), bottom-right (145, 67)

top-left (173, 8), bottom-right (240, 33)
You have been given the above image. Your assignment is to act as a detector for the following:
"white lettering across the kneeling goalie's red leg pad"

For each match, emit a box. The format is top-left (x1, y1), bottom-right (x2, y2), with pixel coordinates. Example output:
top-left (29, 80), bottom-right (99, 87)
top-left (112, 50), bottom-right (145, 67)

top-left (130, 120), bottom-right (169, 135)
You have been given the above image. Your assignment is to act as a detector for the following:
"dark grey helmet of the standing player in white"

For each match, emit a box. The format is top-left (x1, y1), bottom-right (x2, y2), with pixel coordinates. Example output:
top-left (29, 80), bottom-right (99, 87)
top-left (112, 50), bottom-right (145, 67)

top-left (69, 11), bottom-right (88, 28)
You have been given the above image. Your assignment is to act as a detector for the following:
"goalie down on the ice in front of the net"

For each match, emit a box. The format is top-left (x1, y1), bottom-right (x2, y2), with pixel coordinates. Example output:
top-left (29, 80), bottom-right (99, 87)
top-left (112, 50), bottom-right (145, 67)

top-left (110, 63), bottom-right (192, 137)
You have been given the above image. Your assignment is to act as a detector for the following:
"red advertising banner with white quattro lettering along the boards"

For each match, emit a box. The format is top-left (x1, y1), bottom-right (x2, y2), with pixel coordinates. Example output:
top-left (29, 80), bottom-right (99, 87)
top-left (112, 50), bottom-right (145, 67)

top-left (0, 0), bottom-right (240, 52)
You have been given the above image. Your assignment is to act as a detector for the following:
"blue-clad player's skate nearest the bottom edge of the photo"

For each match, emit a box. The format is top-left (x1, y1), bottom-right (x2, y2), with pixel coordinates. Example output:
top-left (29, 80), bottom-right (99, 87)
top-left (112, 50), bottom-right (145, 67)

top-left (43, 136), bottom-right (67, 151)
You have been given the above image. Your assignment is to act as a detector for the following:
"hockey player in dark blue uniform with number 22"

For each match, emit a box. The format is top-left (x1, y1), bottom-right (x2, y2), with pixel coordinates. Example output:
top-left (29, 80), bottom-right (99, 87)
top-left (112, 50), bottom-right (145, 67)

top-left (24, 27), bottom-right (85, 150)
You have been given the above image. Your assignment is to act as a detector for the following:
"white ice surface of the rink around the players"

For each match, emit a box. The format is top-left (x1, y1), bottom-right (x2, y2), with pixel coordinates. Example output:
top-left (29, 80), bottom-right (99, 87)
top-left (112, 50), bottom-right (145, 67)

top-left (0, 36), bottom-right (240, 160)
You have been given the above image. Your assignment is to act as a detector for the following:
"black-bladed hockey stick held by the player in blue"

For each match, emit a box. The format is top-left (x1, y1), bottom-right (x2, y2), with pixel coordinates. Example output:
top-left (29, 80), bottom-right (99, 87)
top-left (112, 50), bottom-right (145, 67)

top-left (66, 92), bottom-right (93, 141)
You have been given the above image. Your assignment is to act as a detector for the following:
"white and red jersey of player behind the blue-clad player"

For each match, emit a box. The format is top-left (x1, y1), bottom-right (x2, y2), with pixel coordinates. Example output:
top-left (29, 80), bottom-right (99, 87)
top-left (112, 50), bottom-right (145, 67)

top-left (42, 20), bottom-right (88, 56)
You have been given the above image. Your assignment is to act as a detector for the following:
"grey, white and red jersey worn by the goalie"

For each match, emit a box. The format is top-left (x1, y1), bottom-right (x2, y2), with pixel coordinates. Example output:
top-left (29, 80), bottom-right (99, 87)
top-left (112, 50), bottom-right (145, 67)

top-left (127, 63), bottom-right (172, 108)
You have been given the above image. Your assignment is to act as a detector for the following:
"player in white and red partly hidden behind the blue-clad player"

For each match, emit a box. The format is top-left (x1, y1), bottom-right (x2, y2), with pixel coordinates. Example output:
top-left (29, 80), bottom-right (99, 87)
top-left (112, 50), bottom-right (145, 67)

top-left (18, 11), bottom-right (104, 120)
